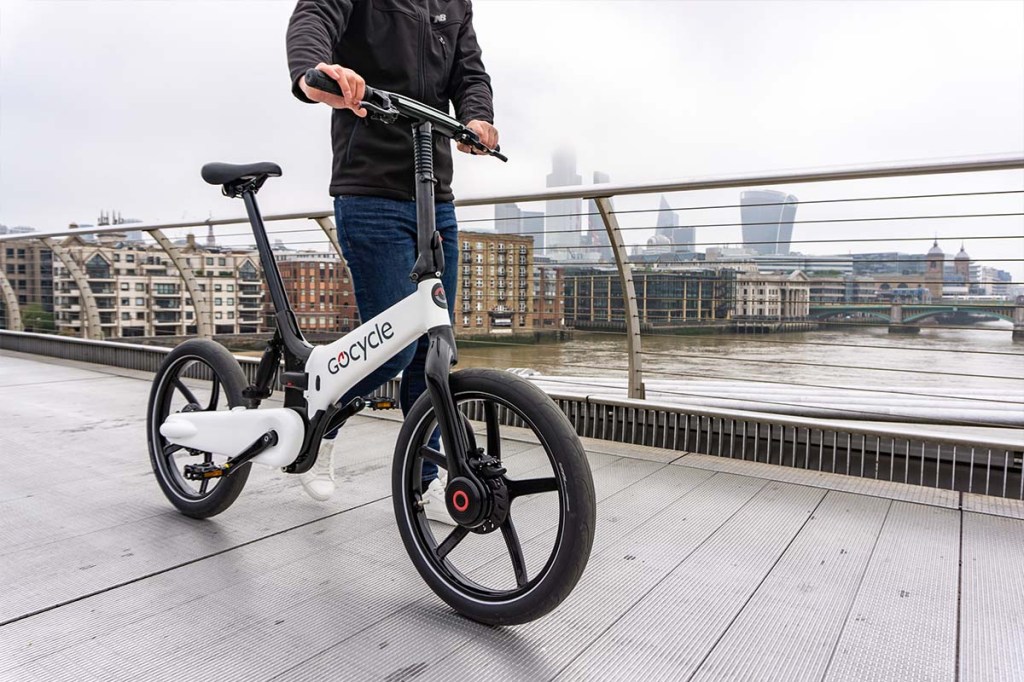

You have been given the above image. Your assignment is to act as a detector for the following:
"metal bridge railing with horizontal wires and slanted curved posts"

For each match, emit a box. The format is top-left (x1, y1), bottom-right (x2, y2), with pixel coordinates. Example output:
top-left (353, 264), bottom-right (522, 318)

top-left (0, 156), bottom-right (1024, 489)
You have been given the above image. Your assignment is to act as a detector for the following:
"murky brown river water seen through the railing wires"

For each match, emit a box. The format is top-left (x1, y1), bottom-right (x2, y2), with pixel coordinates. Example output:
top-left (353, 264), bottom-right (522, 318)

top-left (459, 323), bottom-right (1024, 425)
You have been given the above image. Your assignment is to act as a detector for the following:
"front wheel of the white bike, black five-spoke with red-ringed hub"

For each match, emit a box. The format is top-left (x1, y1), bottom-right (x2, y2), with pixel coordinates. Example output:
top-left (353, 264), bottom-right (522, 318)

top-left (392, 370), bottom-right (596, 625)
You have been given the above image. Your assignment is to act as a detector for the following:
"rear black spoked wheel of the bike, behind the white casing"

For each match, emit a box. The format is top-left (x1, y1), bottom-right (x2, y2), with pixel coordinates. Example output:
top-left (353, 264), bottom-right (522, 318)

top-left (146, 339), bottom-right (251, 518)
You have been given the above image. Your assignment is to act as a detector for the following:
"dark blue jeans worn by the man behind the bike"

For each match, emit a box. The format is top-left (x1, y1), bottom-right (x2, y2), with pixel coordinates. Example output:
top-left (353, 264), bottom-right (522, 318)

top-left (325, 197), bottom-right (459, 482)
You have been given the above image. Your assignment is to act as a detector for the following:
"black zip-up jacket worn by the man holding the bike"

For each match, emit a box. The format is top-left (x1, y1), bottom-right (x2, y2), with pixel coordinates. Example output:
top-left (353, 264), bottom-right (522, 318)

top-left (288, 0), bottom-right (494, 201)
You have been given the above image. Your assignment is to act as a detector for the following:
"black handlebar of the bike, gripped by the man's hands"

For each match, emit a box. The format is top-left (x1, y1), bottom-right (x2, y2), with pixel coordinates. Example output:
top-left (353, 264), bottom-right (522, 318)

top-left (305, 69), bottom-right (508, 162)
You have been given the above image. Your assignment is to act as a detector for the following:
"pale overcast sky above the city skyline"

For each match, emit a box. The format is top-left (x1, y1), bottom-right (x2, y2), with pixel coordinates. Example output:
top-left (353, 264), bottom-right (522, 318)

top-left (0, 0), bottom-right (1024, 280)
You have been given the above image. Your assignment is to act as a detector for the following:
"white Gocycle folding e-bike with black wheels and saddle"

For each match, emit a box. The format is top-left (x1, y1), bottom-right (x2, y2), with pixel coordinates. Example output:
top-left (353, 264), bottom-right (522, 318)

top-left (147, 71), bottom-right (595, 625)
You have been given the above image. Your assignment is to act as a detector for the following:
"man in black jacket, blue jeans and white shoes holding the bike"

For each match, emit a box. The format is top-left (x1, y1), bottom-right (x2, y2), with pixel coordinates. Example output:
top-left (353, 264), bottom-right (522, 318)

top-left (287, 0), bottom-right (498, 523)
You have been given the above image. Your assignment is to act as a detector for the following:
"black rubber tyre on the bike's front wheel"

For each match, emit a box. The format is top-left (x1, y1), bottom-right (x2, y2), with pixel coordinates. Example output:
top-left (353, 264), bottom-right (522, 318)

top-left (392, 369), bottom-right (596, 625)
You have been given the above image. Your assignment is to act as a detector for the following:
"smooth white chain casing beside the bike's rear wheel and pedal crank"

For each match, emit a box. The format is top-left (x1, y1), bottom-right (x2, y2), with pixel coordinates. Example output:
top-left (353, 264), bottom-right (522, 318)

top-left (160, 406), bottom-right (305, 467)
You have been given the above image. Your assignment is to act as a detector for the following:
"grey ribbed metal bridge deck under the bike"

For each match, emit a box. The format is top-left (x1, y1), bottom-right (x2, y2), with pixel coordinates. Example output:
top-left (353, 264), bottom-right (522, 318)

top-left (0, 352), bottom-right (1024, 682)
